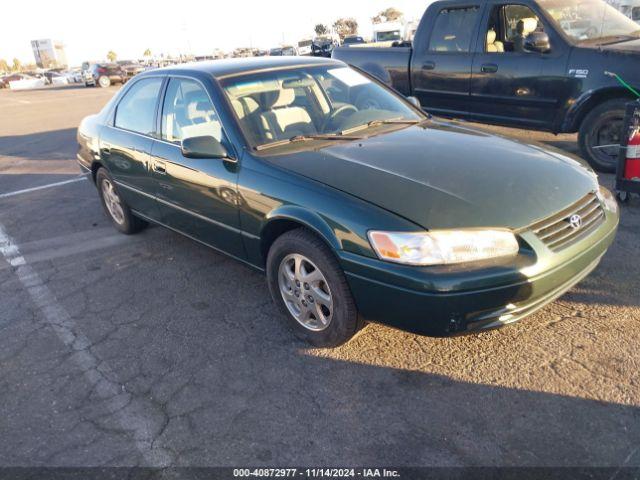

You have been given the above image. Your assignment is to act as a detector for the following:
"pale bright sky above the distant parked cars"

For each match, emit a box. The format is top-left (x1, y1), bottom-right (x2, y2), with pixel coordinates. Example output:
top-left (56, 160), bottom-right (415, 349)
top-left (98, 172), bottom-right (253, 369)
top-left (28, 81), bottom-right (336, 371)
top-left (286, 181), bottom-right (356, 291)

top-left (0, 0), bottom-right (430, 66)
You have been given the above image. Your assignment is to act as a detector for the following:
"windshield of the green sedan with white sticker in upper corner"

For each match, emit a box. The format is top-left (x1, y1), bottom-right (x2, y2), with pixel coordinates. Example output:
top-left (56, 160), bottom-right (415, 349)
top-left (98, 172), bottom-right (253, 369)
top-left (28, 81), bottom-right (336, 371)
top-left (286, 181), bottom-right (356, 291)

top-left (222, 65), bottom-right (426, 147)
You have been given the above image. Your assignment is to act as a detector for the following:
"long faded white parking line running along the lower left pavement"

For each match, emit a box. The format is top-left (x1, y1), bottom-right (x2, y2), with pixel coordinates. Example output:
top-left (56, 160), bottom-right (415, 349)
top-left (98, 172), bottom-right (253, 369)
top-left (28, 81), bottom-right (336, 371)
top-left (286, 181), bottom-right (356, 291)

top-left (0, 225), bottom-right (172, 467)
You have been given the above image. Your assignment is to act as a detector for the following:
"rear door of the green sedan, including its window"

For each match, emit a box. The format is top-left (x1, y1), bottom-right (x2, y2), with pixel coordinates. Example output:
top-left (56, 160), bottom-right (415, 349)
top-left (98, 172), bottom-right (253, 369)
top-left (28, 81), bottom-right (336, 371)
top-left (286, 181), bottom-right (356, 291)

top-left (100, 77), bottom-right (163, 220)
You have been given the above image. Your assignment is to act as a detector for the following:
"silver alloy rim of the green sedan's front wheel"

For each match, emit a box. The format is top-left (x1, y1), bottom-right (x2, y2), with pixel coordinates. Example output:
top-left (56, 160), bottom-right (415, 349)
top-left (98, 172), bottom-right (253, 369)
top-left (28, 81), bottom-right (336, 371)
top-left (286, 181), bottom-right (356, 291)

top-left (278, 253), bottom-right (334, 332)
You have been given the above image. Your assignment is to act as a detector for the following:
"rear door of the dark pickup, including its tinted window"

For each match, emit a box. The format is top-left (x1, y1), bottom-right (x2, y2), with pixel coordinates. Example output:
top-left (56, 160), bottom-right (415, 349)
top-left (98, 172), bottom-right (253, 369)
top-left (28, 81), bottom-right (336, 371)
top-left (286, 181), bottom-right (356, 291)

top-left (411, 3), bottom-right (482, 116)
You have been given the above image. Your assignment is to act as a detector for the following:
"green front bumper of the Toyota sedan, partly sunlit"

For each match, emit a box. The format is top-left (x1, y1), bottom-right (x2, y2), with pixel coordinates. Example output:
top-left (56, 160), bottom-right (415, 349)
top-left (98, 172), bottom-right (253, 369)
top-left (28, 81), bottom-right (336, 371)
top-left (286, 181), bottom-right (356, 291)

top-left (341, 201), bottom-right (619, 337)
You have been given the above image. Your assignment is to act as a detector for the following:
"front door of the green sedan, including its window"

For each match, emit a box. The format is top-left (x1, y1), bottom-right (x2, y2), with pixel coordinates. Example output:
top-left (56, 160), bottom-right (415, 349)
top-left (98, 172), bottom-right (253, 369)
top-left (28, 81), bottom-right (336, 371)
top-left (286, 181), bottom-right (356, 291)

top-left (151, 77), bottom-right (244, 257)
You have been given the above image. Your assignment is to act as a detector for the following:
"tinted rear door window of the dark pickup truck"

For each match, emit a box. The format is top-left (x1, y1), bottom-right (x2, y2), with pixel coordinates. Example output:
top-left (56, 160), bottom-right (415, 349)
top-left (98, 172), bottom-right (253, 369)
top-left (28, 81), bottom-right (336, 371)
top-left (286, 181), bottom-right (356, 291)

top-left (429, 7), bottom-right (480, 53)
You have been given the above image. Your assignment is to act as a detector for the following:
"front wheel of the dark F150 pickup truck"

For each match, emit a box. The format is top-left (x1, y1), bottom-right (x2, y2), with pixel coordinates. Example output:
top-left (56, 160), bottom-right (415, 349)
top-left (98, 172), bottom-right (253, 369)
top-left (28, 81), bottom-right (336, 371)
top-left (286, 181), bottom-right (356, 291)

top-left (578, 98), bottom-right (628, 173)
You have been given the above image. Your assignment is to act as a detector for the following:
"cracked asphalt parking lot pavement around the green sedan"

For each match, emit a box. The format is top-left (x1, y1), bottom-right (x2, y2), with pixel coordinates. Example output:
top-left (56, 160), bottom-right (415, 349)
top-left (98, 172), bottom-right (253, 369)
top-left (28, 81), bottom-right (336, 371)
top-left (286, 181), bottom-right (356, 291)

top-left (0, 83), bottom-right (640, 467)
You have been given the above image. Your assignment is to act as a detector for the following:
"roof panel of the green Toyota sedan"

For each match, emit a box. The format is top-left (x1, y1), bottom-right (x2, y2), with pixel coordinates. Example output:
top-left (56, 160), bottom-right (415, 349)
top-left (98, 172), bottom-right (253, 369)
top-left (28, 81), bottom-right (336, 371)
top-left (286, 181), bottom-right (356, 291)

top-left (142, 57), bottom-right (344, 78)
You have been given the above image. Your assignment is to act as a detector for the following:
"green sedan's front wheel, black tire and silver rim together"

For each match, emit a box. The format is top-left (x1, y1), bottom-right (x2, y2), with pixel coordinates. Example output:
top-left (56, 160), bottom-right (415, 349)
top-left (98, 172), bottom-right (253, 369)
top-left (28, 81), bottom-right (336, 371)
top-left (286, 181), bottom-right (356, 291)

top-left (267, 228), bottom-right (362, 348)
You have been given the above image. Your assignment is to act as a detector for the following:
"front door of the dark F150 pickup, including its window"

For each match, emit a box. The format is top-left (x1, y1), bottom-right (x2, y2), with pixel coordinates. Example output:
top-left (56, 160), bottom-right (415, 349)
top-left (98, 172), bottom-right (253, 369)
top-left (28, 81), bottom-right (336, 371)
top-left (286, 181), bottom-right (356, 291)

top-left (469, 3), bottom-right (569, 129)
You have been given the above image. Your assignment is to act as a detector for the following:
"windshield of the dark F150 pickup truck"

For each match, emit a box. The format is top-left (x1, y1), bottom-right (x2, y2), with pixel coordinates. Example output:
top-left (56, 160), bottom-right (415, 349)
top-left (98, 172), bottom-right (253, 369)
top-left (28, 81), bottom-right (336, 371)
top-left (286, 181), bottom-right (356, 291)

top-left (540, 0), bottom-right (640, 43)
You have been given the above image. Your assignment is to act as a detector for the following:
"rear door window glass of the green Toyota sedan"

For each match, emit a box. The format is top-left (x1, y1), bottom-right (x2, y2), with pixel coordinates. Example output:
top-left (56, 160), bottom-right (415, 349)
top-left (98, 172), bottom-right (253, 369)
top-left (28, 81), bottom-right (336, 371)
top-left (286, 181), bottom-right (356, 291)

top-left (114, 78), bottom-right (162, 135)
